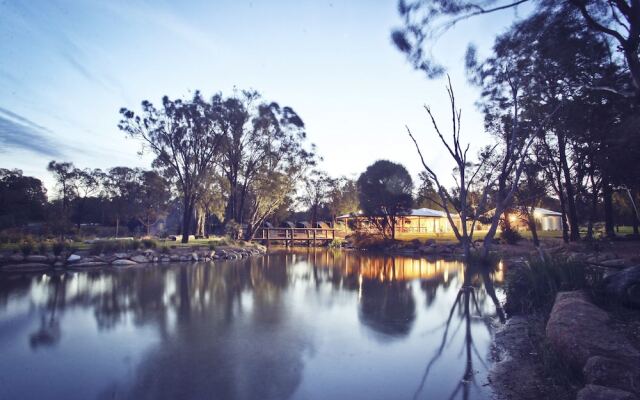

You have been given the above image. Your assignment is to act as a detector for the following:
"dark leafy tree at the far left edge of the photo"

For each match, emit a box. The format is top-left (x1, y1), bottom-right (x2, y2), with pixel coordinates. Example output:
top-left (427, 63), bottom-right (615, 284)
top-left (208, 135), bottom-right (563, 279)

top-left (0, 168), bottom-right (47, 229)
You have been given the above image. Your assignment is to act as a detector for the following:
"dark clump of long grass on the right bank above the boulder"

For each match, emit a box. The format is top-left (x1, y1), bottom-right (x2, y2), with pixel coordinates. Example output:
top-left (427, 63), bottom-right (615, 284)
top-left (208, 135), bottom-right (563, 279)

top-left (505, 259), bottom-right (589, 314)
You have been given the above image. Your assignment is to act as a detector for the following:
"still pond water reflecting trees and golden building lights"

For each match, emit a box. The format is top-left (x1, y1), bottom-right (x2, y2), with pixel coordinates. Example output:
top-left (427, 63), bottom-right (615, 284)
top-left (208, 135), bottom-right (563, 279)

top-left (0, 250), bottom-right (503, 400)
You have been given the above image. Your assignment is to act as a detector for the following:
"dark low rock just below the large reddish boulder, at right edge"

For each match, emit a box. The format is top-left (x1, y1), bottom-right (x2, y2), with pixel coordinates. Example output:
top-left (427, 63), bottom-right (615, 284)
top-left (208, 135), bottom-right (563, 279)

top-left (582, 356), bottom-right (640, 394)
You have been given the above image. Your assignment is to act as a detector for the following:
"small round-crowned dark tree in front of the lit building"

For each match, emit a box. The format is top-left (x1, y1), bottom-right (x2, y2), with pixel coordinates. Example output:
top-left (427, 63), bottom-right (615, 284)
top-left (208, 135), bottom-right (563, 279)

top-left (358, 160), bottom-right (413, 239)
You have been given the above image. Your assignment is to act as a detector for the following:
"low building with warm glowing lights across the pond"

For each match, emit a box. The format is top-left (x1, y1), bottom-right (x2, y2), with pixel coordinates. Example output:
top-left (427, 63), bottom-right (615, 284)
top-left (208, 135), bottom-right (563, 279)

top-left (336, 208), bottom-right (562, 234)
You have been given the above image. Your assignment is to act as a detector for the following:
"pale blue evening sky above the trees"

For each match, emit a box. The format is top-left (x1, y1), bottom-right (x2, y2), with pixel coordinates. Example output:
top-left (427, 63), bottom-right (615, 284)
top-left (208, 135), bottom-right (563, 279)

top-left (0, 0), bottom-right (515, 192)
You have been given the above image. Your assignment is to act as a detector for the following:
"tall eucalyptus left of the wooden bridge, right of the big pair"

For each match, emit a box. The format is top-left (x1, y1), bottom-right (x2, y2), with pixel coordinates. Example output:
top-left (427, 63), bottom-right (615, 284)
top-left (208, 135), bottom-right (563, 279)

top-left (212, 91), bottom-right (315, 238)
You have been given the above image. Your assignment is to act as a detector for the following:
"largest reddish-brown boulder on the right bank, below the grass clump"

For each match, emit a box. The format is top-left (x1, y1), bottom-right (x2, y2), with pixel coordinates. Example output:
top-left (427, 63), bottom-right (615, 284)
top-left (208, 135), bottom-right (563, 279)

top-left (546, 291), bottom-right (640, 369)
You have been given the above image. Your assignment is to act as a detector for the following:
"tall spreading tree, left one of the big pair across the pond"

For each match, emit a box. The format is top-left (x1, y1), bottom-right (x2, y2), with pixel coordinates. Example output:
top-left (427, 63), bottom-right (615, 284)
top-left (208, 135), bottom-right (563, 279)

top-left (118, 92), bottom-right (225, 243)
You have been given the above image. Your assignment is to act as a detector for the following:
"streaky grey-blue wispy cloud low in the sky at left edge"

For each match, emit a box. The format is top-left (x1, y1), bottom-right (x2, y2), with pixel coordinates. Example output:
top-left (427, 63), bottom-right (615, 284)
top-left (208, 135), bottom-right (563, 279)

top-left (0, 108), bottom-right (63, 157)
